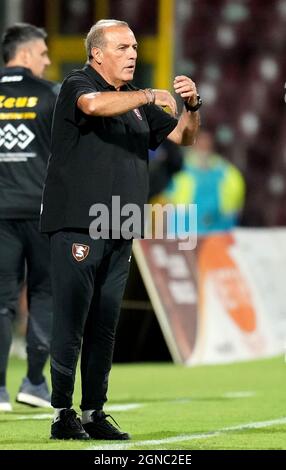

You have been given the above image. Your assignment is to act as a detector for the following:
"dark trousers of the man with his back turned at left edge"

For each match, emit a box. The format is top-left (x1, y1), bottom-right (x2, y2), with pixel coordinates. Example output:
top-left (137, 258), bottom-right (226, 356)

top-left (0, 219), bottom-right (52, 382)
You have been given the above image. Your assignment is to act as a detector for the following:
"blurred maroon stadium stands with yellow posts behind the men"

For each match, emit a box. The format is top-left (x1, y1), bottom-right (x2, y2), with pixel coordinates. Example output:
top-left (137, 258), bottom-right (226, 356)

top-left (0, 0), bottom-right (286, 226)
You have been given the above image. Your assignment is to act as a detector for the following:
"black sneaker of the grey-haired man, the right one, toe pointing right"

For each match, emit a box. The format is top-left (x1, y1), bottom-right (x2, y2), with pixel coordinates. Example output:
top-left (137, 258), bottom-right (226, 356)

top-left (83, 411), bottom-right (130, 441)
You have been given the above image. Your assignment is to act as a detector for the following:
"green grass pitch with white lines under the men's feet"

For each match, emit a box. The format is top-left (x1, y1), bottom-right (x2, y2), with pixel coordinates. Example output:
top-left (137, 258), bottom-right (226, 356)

top-left (0, 356), bottom-right (286, 450)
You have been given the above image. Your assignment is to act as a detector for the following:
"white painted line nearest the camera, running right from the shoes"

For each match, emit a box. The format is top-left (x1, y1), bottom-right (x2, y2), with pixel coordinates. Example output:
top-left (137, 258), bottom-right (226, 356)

top-left (85, 417), bottom-right (286, 450)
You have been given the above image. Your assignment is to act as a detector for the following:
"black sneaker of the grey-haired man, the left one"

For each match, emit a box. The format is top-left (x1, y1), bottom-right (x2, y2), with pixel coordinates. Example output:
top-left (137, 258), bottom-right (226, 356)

top-left (51, 409), bottom-right (89, 440)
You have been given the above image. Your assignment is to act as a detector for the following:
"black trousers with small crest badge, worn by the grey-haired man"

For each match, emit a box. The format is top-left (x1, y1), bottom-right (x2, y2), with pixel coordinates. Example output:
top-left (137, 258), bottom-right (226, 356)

top-left (50, 231), bottom-right (132, 410)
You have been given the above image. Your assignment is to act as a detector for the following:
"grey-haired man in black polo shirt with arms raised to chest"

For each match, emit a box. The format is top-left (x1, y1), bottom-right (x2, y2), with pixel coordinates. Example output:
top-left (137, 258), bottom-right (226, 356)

top-left (41, 20), bottom-right (200, 440)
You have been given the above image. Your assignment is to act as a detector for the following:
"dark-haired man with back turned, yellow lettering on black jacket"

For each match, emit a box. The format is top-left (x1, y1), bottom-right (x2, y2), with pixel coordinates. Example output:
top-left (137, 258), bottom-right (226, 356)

top-left (0, 23), bottom-right (58, 411)
